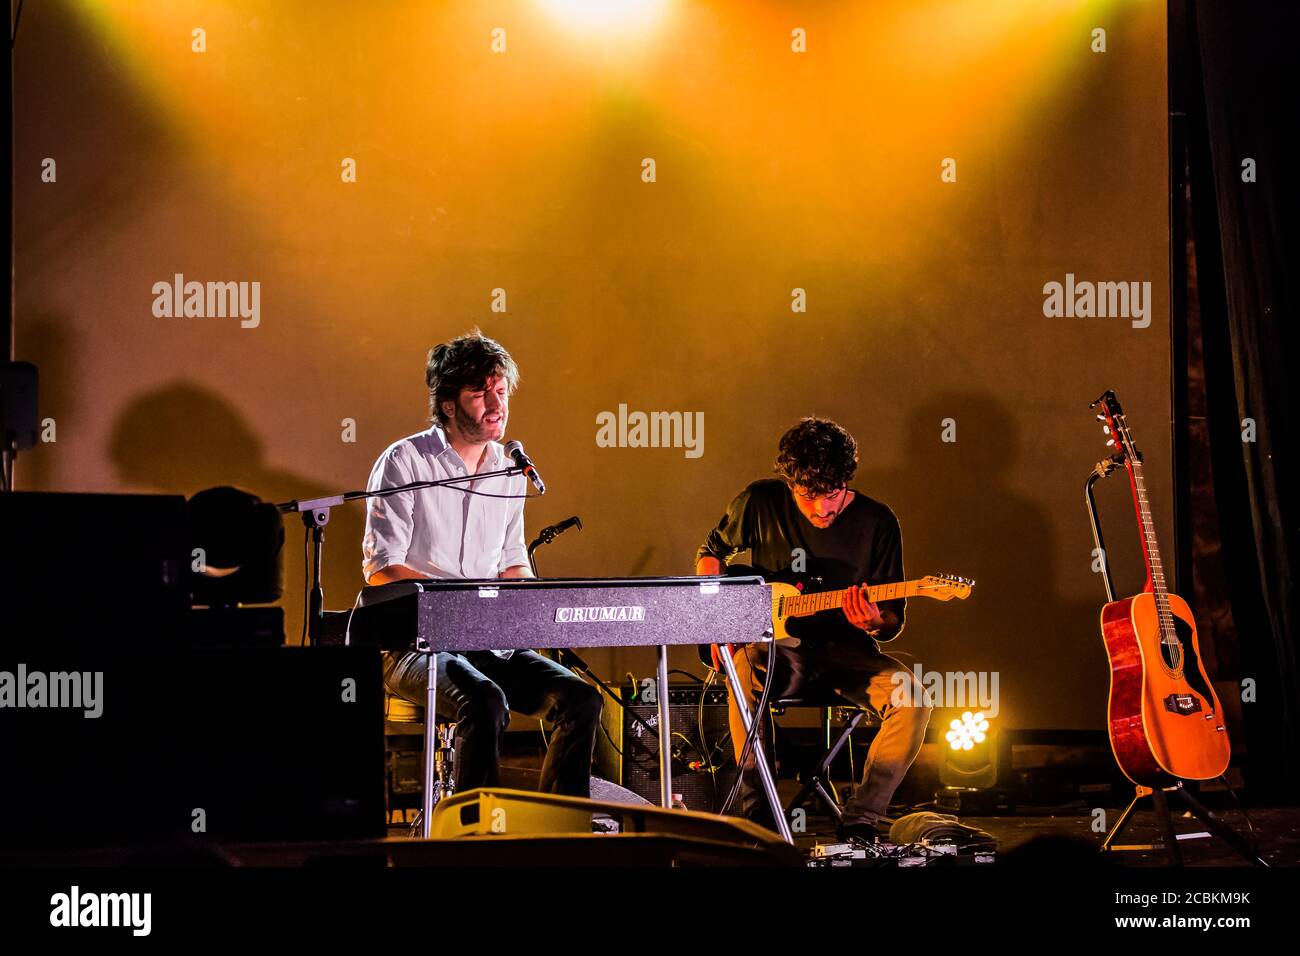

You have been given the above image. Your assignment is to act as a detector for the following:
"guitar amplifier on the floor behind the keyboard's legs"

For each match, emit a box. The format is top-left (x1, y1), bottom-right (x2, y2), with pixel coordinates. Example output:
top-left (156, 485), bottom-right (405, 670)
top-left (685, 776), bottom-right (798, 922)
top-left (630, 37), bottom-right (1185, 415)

top-left (595, 683), bottom-right (736, 813)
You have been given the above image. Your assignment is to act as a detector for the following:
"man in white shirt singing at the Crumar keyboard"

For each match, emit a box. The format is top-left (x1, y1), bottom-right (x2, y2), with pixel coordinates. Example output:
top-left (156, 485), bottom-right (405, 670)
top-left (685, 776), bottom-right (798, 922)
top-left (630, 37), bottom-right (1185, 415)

top-left (361, 330), bottom-right (601, 796)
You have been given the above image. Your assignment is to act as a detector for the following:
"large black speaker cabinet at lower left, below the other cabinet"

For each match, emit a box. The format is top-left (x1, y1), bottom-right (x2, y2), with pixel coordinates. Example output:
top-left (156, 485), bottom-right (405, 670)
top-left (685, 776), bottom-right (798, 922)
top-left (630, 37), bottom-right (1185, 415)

top-left (0, 646), bottom-right (386, 858)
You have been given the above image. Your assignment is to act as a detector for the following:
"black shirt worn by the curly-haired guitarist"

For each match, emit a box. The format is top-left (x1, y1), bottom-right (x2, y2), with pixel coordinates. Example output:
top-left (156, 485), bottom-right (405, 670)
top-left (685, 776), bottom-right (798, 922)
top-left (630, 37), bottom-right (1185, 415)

top-left (696, 479), bottom-right (906, 650)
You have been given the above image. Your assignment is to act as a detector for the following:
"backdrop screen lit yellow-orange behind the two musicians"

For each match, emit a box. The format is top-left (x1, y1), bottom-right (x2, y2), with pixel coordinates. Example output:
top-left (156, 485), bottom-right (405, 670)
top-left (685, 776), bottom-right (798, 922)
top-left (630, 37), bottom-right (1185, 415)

top-left (13, 0), bottom-right (1173, 727)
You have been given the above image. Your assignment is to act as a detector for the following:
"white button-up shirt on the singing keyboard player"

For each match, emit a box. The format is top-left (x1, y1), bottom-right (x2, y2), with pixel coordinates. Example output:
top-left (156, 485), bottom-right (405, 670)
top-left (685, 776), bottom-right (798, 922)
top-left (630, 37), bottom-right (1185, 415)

top-left (361, 424), bottom-right (529, 608)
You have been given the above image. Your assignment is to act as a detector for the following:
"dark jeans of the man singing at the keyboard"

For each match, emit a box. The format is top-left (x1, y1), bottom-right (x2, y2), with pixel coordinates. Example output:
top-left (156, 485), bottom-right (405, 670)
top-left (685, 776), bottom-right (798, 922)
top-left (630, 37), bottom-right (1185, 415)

top-left (384, 650), bottom-right (601, 797)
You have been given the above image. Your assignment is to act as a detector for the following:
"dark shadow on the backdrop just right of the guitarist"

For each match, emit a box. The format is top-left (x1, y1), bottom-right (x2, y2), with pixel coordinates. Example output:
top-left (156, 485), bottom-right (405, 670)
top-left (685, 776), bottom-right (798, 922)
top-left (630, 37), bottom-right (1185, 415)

top-left (854, 392), bottom-right (1109, 728)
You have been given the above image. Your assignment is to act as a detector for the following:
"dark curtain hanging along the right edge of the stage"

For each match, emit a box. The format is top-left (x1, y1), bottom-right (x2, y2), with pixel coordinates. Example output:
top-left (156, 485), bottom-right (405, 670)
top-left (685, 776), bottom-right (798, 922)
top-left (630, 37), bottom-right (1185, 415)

top-left (1169, 0), bottom-right (1300, 803)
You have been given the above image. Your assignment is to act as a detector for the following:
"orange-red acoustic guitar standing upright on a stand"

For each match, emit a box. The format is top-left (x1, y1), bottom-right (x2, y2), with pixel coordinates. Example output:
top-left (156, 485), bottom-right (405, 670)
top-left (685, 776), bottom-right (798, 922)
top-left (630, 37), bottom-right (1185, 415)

top-left (1092, 392), bottom-right (1231, 787)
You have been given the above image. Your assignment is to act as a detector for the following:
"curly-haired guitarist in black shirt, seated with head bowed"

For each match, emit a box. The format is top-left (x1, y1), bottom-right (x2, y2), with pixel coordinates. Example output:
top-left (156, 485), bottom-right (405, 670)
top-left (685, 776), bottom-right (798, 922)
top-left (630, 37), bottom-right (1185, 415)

top-left (696, 418), bottom-right (931, 839)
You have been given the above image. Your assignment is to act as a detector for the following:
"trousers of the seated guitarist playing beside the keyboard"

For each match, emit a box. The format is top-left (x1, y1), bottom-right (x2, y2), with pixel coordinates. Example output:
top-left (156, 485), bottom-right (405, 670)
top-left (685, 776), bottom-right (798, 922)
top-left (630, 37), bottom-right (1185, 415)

top-left (729, 644), bottom-right (932, 826)
